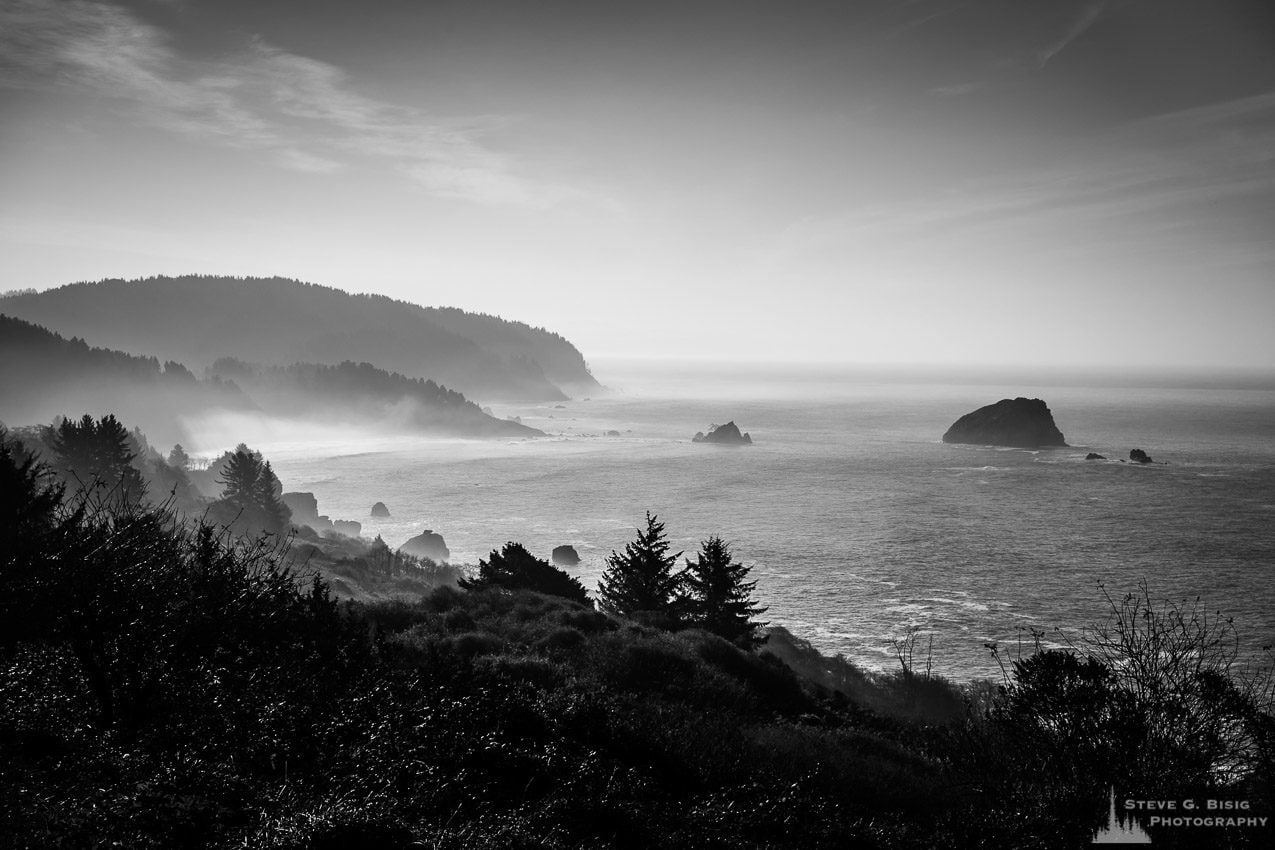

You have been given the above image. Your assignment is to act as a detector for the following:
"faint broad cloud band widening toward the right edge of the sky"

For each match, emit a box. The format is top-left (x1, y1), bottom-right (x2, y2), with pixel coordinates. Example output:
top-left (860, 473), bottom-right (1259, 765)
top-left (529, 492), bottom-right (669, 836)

top-left (768, 92), bottom-right (1275, 265)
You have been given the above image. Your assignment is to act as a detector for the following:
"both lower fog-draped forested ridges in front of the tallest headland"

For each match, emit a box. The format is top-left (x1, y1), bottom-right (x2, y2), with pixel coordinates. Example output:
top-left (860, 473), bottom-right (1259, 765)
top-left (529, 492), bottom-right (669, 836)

top-left (0, 316), bottom-right (541, 445)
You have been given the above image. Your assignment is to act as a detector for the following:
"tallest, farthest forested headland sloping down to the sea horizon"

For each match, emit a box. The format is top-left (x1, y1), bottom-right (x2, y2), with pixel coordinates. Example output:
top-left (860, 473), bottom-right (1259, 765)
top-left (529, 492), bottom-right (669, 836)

top-left (0, 275), bottom-right (601, 401)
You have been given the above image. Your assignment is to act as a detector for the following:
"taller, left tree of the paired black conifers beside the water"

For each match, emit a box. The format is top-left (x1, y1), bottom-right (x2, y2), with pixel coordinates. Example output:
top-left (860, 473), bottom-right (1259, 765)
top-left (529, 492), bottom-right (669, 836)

top-left (598, 511), bottom-right (682, 617)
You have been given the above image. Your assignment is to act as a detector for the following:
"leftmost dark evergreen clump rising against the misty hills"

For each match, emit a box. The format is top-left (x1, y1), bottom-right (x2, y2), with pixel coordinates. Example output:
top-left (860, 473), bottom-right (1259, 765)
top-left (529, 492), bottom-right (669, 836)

top-left (46, 413), bottom-right (145, 501)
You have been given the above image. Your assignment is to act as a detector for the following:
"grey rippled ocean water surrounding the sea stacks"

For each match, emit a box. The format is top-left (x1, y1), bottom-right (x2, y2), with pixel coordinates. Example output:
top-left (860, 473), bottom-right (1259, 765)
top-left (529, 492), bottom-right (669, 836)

top-left (252, 363), bottom-right (1275, 681)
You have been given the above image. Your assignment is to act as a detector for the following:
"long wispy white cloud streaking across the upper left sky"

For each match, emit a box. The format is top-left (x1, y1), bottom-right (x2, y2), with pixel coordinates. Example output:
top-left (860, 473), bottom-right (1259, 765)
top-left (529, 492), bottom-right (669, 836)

top-left (0, 0), bottom-right (588, 208)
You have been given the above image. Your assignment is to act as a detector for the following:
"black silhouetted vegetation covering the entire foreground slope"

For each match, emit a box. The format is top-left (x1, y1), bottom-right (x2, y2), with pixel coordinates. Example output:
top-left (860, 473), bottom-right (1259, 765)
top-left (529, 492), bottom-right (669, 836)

top-left (0, 419), bottom-right (1275, 850)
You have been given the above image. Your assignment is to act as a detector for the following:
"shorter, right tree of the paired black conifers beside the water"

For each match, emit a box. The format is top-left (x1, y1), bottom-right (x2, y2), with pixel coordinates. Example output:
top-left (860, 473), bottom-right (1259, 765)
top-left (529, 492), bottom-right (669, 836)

top-left (682, 535), bottom-right (766, 649)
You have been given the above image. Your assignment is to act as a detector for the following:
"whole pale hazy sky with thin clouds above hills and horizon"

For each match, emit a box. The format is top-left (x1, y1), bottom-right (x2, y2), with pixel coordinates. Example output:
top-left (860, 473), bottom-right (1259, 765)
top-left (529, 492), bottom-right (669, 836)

top-left (0, 0), bottom-right (1275, 370)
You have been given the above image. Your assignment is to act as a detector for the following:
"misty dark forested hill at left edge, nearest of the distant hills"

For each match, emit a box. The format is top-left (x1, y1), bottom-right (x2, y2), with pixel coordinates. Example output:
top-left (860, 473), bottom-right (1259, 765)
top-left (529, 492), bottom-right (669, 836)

top-left (0, 315), bottom-right (259, 445)
